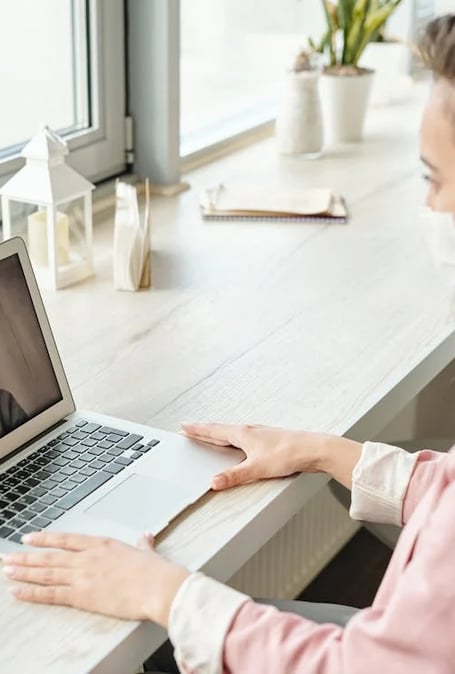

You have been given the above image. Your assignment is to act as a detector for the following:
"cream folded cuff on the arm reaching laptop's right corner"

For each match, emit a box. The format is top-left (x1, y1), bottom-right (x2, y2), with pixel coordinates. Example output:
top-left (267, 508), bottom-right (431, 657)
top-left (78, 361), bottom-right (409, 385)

top-left (349, 442), bottom-right (418, 526)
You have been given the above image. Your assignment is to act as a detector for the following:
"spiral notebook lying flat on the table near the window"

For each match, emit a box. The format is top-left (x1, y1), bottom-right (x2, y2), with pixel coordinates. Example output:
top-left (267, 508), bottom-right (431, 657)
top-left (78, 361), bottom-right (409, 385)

top-left (200, 185), bottom-right (348, 224)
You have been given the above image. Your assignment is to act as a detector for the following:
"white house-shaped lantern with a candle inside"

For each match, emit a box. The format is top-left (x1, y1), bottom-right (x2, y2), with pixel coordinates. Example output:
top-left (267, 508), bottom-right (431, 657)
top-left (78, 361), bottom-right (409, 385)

top-left (0, 127), bottom-right (94, 290)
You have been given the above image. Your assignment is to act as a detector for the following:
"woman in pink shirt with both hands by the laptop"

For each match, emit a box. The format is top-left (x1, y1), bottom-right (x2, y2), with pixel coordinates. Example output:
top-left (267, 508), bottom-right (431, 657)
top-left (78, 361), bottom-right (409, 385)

top-left (4, 15), bottom-right (455, 674)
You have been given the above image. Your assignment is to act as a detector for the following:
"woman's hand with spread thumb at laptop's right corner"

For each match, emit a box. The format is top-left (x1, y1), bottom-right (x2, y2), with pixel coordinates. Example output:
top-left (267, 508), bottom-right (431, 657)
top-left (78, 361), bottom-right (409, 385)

top-left (182, 423), bottom-right (362, 490)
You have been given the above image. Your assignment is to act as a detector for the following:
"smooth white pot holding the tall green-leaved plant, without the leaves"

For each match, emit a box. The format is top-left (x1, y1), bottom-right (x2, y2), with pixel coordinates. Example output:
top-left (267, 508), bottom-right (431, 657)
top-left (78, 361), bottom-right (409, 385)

top-left (321, 71), bottom-right (374, 144)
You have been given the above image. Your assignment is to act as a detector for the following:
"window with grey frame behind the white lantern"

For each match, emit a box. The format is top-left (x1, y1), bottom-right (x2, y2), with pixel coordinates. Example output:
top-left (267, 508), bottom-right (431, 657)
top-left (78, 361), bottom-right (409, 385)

top-left (0, 0), bottom-right (125, 180)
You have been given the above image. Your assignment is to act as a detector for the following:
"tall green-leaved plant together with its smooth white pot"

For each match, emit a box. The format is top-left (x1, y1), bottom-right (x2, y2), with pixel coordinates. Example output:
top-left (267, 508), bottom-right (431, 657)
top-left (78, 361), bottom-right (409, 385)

top-left (310, 0), bottom-right (401, 142)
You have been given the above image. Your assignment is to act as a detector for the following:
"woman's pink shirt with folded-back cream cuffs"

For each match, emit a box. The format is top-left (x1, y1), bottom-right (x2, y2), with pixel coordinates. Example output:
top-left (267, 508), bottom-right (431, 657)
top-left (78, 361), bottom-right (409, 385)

top-left (169, 443), bottom-right (455, 674)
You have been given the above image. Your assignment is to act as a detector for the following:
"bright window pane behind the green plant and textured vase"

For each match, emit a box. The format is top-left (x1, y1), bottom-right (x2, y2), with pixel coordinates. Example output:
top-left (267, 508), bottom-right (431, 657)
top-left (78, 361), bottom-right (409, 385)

top-left (180, 0), bottom-right (324, 156)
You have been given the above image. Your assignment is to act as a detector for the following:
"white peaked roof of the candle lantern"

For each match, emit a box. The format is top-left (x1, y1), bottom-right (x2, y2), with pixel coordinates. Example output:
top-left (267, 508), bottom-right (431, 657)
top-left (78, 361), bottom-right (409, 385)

top-left (0, 127), bottom-right (95, 205)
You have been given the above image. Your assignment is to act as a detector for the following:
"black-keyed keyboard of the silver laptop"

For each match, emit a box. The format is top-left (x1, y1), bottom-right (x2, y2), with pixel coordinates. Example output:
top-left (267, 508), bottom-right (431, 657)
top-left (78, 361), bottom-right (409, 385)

top-left (0, 419), bottom-right (159, 543)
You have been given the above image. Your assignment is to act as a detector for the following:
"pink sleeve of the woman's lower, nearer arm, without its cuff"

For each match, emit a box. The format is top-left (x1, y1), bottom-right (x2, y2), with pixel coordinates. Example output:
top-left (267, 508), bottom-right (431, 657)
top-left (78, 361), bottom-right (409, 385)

top-left (224, 483), bottom-right (455, 674)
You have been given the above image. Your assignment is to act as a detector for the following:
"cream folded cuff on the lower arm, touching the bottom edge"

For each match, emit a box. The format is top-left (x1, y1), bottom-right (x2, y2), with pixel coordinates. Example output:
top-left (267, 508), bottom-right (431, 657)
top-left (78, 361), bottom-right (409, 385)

top-left (168, 573), bottom-right (250, 674)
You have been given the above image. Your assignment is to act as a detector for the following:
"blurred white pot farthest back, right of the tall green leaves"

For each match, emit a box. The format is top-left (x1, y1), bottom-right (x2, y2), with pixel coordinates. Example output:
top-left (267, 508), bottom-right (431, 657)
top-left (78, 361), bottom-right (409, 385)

top-left (360, 42), bottom-right (412, 105)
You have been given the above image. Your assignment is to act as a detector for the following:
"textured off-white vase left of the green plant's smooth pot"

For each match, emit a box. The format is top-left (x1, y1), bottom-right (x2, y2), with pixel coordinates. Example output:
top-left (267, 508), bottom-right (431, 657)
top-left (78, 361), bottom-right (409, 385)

top-left (275, 70), bottom-right (323, 158)
